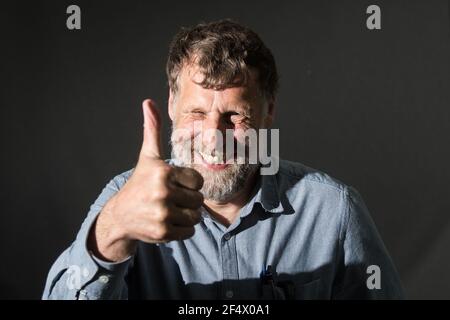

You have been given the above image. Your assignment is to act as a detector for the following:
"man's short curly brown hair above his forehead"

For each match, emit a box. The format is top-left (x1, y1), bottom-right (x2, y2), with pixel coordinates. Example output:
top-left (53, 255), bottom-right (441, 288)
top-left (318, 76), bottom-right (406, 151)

top-left (166, 19), bottom-right (278, 99)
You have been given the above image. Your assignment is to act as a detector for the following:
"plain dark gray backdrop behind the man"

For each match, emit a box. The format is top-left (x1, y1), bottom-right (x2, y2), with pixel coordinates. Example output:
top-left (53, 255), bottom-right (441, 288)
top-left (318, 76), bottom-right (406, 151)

top-left (0, 0), bottom-right (450, 298)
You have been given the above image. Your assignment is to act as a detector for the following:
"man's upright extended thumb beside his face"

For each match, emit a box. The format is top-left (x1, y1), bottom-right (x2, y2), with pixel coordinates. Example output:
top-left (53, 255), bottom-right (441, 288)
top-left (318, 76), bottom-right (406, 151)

top-left (141, 99), bottom-right (162, 159)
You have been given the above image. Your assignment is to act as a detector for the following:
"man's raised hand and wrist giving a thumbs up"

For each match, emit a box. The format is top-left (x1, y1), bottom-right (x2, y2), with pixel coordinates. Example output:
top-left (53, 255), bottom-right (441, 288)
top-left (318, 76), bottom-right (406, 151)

top-left (88, 99), bottom-right (203, 261)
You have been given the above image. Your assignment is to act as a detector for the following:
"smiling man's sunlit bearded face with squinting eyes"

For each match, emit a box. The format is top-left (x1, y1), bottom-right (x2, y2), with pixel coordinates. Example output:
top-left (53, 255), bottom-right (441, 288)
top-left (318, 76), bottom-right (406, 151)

top-left (169, 66), bottom-right (273, 201)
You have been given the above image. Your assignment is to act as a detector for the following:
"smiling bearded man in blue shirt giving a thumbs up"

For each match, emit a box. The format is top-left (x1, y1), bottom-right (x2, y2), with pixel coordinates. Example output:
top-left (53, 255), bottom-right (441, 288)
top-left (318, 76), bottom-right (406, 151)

top-left (43, 20), bottom-right (402, 299)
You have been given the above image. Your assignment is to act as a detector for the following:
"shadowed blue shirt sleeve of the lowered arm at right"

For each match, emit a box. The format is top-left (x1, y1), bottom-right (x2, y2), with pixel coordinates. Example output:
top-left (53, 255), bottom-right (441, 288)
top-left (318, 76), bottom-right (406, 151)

top-left (333, 187), bottom-right (404, 299)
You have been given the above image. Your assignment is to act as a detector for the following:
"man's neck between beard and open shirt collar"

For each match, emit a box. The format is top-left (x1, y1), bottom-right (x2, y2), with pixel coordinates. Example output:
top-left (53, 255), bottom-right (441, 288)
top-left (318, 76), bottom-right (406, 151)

top-left (204, 170), bottom-right (259, 227)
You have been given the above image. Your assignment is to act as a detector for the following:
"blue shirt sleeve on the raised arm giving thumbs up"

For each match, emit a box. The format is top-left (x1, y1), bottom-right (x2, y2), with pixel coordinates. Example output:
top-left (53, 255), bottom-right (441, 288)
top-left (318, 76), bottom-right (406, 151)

top-left (42, 172), bottom-right (132, 300)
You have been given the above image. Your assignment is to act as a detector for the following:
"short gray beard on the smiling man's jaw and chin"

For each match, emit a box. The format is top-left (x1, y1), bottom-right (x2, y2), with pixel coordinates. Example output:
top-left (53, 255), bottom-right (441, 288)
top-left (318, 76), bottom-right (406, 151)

top-left (171, 129), bottom-right (259, 202)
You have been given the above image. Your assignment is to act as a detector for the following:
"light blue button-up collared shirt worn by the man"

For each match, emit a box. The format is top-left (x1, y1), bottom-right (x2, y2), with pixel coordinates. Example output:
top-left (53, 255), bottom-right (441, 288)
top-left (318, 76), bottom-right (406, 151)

top-left (43, 160), bottom-right (403, 299)
